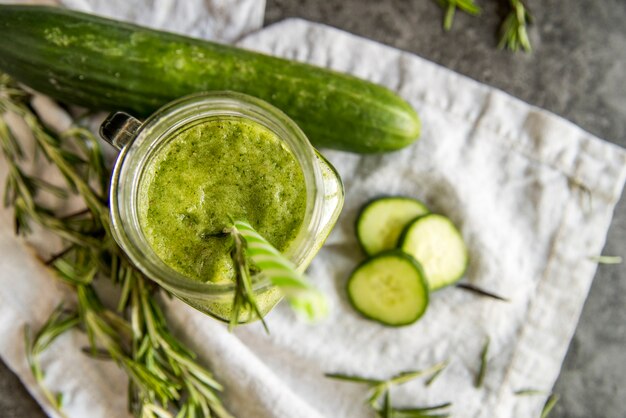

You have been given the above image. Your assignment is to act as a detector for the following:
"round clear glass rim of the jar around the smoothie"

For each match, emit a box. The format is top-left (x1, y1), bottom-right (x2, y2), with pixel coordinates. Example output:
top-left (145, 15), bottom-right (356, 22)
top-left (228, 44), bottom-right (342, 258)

top-left (109, 91), bottom-right (324, 297)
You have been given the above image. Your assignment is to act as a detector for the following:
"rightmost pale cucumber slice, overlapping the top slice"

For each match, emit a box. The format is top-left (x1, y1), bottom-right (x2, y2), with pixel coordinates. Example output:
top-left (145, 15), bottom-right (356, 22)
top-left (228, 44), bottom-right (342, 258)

top-left (400, 214), bottom-right (468, 290)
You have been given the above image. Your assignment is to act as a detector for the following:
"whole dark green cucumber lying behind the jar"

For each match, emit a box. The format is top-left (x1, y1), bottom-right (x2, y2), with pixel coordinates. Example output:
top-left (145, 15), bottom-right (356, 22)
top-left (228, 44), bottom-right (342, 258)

top-left (0, 5), bottom-right (420, 153)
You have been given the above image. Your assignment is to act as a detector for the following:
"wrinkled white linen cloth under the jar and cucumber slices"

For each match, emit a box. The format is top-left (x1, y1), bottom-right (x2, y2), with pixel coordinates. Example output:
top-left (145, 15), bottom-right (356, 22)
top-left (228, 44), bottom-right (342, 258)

top-left (0, 5), bottom-right (626, 418)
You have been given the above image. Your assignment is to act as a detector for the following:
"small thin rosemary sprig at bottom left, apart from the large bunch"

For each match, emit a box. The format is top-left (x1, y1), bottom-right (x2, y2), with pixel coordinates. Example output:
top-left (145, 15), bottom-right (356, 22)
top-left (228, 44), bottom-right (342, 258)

top-left (24, 305), bottom-right (80, 417)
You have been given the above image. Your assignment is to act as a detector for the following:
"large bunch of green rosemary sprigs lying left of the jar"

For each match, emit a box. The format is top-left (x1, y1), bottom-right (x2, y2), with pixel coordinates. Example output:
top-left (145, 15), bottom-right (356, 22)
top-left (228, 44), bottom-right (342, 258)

top-left (0, 74), bottom-right (230, 418)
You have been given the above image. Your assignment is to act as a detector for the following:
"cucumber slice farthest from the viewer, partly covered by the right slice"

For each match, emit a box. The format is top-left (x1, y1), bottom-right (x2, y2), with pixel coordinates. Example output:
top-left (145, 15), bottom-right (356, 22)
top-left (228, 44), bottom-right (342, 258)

top-left (356, 196), bottom-right (429, 255)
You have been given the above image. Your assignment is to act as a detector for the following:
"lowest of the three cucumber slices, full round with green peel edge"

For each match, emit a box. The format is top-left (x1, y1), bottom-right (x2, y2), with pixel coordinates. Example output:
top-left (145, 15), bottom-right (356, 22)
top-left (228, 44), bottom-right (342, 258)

top-left (348, 250), bottom-right (428, 326)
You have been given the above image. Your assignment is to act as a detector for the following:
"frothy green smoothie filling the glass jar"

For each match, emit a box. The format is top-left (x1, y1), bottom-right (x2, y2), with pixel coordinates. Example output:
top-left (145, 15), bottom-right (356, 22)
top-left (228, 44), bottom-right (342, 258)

top-left (138, 117), bottom-right (306, 290)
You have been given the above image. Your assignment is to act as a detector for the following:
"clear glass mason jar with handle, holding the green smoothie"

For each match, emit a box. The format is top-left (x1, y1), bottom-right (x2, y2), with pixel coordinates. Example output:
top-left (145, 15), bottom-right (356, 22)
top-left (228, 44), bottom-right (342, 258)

top-left (100, 92), bottom-right (344, 322)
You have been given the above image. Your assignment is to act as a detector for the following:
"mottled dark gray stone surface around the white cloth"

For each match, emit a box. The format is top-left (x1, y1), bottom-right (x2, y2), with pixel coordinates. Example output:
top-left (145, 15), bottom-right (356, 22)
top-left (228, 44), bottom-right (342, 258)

top-left (0, 0), bottom-right (626, 418)
